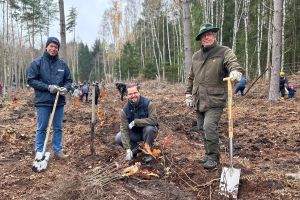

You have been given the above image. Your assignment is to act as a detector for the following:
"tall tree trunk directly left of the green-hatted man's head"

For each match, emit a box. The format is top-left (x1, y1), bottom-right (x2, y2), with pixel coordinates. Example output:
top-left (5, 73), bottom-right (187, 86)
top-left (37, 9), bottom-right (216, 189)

top-left (182, 0), bottom-right (192, 81)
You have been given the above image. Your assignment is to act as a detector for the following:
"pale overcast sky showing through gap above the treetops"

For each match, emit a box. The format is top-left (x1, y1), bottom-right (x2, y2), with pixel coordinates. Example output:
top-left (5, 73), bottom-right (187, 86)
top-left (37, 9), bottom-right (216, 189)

top-left (50, 0), bottom-right (112, 47)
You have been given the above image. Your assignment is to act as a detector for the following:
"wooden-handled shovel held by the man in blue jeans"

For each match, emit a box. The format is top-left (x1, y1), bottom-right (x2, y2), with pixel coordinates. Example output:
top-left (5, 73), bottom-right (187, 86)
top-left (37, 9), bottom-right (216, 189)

top-left (32, 92), bottom-right (59, 172)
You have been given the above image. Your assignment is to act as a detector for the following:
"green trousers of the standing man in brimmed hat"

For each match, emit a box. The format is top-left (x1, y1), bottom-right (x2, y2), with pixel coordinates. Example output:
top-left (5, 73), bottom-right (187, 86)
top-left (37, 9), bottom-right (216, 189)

top-left (196, 108), bottom-right (223, 162)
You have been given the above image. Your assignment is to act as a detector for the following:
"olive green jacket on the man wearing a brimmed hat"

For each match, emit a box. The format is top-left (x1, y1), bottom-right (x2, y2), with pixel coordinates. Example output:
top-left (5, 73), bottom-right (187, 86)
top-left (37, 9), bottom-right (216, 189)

top-left (186, 44), bottom-right (243, 112)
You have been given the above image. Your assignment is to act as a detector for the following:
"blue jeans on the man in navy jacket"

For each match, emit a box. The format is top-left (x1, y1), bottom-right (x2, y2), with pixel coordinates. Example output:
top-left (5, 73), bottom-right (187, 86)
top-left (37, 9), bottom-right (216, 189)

top-left (35, 106), bottom-right (64, 154)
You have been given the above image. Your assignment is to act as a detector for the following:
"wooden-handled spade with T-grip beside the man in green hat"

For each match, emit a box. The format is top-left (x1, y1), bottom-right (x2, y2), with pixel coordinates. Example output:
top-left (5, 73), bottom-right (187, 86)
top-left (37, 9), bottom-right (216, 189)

top-left (219, 77), bottom-right (241, 199)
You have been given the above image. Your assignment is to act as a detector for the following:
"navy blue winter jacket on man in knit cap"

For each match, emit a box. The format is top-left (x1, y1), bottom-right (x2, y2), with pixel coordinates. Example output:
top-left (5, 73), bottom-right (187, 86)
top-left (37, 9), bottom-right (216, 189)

top-left (27, 51), bottom-right (72, 107)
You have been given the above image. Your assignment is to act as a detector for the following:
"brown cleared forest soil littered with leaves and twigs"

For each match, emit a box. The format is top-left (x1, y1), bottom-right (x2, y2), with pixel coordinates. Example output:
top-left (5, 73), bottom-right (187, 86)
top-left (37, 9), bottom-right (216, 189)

top-left (0, 74), bottom-right (300, 200)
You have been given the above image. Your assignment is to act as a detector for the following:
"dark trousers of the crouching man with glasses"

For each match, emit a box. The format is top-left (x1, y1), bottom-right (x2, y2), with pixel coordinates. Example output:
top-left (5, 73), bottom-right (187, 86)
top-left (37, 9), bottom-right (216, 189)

top-left (115, 126), bottom-right (158, 152)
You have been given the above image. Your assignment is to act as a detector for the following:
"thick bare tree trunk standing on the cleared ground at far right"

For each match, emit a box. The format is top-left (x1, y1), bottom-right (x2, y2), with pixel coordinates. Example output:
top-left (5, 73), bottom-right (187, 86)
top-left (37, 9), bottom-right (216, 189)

top-left (269, 0), bottom-right (283, 101)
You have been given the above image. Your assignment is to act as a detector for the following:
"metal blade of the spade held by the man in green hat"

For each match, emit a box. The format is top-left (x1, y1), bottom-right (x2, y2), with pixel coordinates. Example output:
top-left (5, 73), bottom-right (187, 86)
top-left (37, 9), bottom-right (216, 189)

top-left (219, 167), bottom-right (241, 199)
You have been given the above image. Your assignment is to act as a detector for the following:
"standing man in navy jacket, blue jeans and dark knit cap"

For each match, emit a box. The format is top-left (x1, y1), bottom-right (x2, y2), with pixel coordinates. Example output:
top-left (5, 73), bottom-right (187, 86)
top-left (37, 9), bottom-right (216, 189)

top-left (27, 37), bottom-right (72, 160)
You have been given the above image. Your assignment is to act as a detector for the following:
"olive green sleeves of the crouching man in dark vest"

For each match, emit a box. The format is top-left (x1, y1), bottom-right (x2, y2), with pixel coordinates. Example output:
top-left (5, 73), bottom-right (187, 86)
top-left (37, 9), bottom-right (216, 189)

top-left (120, 101), bottom-right (157, 149)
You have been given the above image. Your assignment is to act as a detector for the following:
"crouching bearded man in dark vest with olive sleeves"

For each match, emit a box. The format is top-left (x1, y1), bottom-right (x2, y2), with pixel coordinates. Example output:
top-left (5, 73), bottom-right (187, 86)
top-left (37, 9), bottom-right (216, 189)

top-left (115, 84), bottom-right (158, 160)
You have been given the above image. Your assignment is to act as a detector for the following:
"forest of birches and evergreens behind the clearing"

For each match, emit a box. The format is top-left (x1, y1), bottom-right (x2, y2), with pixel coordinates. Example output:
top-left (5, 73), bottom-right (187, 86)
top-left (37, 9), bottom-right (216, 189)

top-left (0, 0), bottom-right (300, 87)
